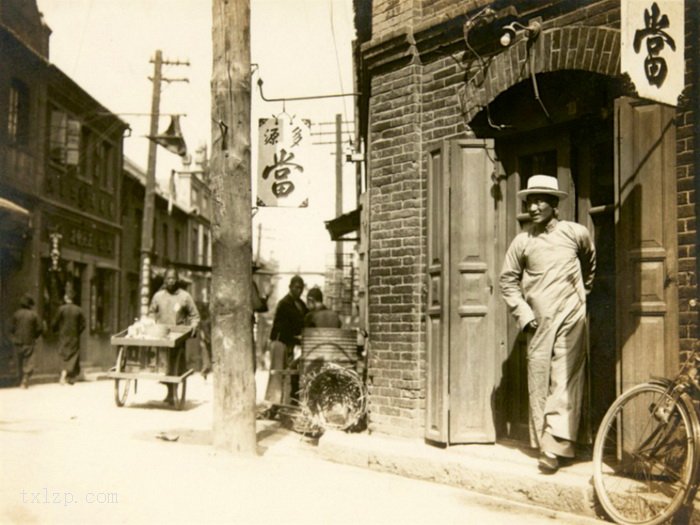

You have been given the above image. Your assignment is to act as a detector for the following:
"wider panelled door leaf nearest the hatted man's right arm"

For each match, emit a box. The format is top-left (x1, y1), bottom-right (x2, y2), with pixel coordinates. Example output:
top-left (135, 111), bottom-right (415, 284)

top-left (449, 140), bottom-right (500, 443)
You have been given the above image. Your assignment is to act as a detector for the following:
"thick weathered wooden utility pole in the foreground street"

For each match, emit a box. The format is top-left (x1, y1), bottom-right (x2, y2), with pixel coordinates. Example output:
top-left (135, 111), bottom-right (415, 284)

top-left (211, 0), bottom-right (257, 455)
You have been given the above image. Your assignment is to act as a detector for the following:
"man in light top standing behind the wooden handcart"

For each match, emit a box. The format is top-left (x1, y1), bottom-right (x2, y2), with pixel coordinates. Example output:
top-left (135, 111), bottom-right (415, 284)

top-left (149, 266), bottom-right (199, 405)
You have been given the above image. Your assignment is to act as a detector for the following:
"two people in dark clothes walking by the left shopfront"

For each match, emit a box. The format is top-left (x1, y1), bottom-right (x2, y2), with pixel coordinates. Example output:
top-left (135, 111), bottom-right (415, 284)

top-left (9, 290), bottom-right (85, 388)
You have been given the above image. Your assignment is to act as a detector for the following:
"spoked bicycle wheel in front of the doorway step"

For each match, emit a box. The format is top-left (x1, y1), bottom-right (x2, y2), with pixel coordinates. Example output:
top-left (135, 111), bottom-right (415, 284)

top-left (593, 383), bottom-right (698, 525)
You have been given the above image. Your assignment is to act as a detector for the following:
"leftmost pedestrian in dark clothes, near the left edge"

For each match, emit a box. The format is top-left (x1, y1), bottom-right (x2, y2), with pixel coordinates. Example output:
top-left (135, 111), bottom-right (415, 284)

top-left (10, 294), bottom-right (44, 388)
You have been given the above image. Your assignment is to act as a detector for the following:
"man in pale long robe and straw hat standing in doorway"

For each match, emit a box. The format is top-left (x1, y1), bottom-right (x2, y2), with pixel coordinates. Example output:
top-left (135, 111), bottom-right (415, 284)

top-left (500, 175), bottom-right (596, 474)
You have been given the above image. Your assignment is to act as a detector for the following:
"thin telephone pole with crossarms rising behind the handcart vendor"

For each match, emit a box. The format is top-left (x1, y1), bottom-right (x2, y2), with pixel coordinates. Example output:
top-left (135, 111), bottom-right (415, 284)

top-left (139, 49), bottom-right (190, 317)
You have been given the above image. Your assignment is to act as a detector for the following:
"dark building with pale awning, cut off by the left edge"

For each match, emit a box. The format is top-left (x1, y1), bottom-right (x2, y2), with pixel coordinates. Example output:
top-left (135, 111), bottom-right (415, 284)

top-left (0, 2), bottom-right (51, 384)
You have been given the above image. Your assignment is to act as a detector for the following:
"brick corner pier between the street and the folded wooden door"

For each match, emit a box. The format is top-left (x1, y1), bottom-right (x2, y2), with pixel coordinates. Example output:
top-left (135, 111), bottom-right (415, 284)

top-left (368, 65), bottom-right (425, 436)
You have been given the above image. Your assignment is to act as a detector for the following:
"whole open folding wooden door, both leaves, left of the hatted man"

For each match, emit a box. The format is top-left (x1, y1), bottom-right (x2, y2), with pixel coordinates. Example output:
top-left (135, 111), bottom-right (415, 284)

top-left (426, 139), bottom-right (505, 444)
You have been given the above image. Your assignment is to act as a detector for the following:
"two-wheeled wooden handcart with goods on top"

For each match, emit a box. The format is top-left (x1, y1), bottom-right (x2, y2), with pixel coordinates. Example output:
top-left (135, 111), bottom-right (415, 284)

top-left (106, 325), bottom-right (194, 410)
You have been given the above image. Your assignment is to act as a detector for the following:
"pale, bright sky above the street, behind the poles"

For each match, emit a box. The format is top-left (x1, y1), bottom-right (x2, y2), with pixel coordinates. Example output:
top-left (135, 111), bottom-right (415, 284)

top-left (37, 0), bottom-right (356, 282)
